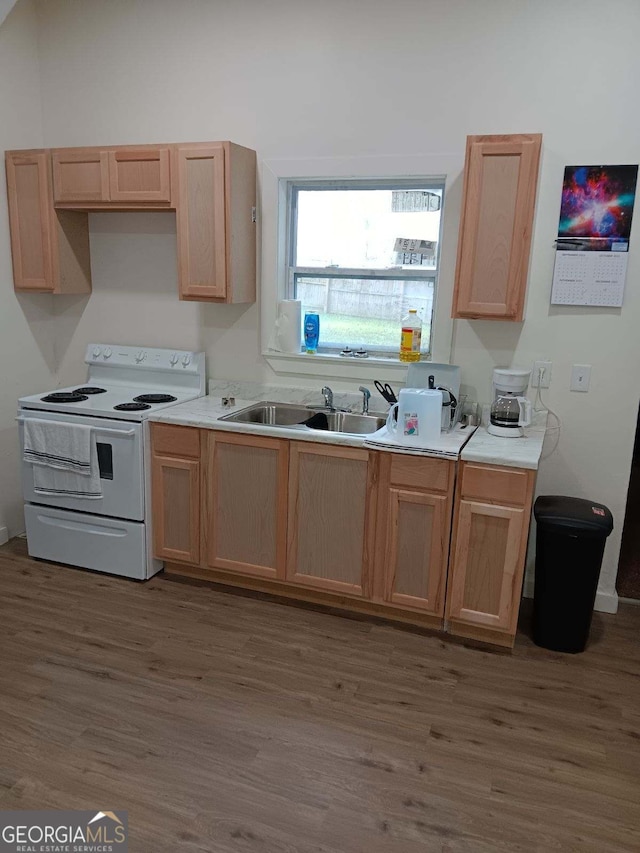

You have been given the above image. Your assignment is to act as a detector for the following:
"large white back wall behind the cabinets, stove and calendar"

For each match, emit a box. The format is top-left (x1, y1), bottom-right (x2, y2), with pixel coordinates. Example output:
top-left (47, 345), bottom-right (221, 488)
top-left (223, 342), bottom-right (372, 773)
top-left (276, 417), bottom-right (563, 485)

top-left (6, 0), bottom-right (640, 596)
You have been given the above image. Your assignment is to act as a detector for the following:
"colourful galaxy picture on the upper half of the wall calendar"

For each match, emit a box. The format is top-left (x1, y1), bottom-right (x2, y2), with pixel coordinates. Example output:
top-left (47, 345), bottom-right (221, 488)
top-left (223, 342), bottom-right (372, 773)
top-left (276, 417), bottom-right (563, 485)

top-left (557, 165), bottom-right (638, 252)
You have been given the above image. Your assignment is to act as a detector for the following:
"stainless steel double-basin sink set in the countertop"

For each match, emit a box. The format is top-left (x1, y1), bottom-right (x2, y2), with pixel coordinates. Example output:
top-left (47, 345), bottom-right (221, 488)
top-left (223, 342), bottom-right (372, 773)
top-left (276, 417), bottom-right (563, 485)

top-left (220, 400), bottom-right (387, 435)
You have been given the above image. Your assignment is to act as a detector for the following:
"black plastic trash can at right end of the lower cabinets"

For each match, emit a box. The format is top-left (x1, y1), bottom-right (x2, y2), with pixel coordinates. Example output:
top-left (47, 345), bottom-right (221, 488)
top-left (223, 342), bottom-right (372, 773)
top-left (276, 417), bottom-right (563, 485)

top-left (533, 495), bottom-right (613, 652)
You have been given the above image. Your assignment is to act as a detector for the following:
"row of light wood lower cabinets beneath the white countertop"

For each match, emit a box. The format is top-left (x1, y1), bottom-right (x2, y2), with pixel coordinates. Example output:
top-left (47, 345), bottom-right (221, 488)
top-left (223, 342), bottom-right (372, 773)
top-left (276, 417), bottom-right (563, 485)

top-left (151, 424), bottom-right (535, 647)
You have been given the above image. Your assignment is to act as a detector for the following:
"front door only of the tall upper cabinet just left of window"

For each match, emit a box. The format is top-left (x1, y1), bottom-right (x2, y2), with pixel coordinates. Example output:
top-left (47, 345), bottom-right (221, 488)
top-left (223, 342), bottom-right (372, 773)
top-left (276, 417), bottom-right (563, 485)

top-left (171, 144), bottom-right (227, 301)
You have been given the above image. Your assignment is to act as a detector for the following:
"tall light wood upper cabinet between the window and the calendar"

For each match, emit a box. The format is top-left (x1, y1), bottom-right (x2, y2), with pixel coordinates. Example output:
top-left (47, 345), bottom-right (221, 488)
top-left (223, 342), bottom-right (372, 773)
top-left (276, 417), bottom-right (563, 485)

top-left (452, 133), bottom-right (542, 320)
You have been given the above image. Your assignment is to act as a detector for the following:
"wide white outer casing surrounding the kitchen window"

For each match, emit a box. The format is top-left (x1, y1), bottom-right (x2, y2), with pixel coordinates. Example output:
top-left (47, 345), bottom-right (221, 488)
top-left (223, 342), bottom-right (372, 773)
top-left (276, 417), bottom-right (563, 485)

top-left (259, 149), bottom-right (464, 382)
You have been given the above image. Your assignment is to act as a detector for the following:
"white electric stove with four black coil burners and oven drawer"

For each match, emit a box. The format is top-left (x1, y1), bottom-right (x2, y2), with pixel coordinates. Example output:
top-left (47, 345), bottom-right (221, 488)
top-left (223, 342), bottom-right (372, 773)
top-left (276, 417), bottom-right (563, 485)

top-left (18, 344), bottom-right (206, 580)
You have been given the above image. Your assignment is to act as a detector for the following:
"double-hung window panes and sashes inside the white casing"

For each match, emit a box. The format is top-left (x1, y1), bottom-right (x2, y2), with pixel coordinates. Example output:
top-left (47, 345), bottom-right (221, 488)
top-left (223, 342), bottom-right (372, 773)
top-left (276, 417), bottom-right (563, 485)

top-left (286, 179), bottom-right (444, 359)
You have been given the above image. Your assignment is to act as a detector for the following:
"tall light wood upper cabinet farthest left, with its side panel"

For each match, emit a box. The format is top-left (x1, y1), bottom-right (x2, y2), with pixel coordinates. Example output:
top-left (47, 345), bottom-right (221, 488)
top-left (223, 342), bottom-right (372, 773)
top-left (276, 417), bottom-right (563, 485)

top-left (5, 151), bottom-right (91, 293)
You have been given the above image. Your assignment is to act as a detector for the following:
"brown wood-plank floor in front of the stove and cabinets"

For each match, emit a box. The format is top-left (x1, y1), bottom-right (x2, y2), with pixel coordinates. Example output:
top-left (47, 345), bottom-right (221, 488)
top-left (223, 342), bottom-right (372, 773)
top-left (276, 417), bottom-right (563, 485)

top-left (0, 540), bottom-right (640, 853)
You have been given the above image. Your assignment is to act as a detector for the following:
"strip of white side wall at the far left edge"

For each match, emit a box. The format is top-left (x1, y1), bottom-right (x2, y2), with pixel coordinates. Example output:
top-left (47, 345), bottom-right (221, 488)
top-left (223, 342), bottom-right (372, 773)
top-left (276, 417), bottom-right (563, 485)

top-left (0, 0), bottom-right (54, 541)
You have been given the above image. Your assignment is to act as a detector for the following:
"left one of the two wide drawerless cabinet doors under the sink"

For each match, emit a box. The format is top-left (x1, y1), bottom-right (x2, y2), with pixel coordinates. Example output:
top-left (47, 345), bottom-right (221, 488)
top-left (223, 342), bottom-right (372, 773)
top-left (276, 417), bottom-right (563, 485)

top-left (205, 432), bottom-right (288, 580)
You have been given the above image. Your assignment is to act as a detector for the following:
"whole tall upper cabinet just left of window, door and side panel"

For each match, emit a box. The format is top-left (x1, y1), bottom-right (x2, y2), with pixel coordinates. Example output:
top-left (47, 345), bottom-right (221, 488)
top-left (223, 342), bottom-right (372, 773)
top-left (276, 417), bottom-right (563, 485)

top-left (171, 142), bottom-right (256, 302)
